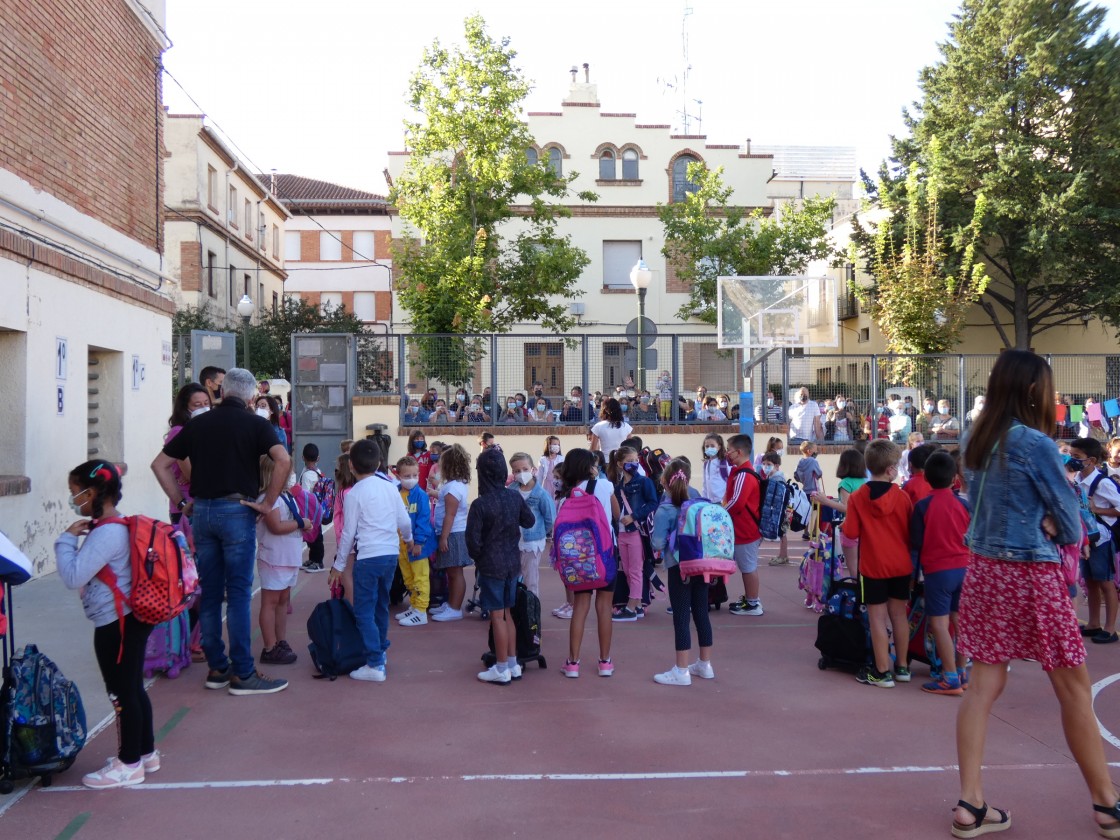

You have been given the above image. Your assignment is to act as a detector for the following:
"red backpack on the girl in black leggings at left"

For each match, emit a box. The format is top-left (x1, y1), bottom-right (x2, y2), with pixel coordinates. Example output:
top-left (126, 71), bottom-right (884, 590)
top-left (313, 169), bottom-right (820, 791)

top-left (97, 516), bottom-right (198, 640)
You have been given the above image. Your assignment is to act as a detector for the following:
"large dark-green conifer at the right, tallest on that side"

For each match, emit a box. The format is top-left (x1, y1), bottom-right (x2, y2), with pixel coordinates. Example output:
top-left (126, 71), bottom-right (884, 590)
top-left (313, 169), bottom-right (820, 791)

top-left (857, 0), bottom-right (1120, 348)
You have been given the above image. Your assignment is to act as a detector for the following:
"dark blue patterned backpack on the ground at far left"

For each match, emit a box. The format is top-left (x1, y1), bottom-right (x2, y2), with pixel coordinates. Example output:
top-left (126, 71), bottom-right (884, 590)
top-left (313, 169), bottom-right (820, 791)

top-left (0, 643), bottom-right (86, 783)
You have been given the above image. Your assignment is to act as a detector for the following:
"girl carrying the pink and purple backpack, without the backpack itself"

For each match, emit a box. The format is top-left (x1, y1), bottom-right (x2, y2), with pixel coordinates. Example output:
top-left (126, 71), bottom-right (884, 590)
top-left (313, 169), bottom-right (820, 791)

top-left (553, 449), bottom-right (618, 679)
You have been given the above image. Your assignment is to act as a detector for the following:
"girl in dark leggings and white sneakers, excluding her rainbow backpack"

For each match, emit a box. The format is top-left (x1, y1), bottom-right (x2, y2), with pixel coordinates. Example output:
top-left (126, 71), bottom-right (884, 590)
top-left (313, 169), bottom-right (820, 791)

top-left (651, 461), bottom-right (716, 685)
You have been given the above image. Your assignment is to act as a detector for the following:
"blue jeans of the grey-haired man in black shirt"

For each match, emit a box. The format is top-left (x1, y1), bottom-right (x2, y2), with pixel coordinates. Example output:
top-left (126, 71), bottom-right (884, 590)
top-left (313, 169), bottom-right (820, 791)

top-left (190, 498), bottom-right (256, 678)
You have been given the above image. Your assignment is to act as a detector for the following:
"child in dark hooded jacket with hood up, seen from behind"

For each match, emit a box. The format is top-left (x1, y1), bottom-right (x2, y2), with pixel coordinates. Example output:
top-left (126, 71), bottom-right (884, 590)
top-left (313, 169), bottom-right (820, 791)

top-left (465, 447), bottom-right (533, 685)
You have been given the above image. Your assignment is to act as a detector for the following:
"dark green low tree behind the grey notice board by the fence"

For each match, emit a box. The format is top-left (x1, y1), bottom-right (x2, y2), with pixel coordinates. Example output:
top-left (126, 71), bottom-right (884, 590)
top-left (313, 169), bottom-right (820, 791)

top-left (243, 296), bottom-right (365, 380)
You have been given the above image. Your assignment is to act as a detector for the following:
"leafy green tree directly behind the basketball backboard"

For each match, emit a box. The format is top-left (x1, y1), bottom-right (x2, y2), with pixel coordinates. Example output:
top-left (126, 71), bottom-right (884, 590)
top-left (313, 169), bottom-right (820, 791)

top-left (657, 164), bottom-right (836, 324)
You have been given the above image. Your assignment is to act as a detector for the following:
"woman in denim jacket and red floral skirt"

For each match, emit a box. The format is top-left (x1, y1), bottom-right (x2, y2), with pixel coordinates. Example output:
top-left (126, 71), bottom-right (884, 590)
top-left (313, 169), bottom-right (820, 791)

top-left (952, 351), bottom-right (1120, 838)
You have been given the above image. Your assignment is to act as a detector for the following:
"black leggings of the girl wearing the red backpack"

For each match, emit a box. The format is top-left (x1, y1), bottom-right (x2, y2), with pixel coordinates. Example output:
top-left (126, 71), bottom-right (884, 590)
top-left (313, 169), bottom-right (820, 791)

top-left (93, 613), bottom-right (156, 764)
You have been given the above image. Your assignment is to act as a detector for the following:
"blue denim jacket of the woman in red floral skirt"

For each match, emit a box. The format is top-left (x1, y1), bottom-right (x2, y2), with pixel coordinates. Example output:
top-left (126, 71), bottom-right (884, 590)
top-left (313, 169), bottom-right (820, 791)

top-left (964, 423), bottom-right (1081, 563)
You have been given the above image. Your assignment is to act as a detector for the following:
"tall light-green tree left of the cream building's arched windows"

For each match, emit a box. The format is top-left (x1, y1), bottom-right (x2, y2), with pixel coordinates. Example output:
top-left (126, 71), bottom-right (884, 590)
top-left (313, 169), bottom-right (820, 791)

top-left (390, 16), bottom-right (594, 384)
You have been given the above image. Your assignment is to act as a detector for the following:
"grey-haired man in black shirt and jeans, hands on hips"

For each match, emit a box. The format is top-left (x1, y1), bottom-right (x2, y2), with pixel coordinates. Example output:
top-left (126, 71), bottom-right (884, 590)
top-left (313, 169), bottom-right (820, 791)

top-left (151, 367), bottom-right (291, 696)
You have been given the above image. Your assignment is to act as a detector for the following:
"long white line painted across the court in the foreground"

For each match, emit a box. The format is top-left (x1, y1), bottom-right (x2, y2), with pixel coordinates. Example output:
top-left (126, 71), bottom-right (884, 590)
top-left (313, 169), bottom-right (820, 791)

top-left (40, 762), bottom-right (1102, 793)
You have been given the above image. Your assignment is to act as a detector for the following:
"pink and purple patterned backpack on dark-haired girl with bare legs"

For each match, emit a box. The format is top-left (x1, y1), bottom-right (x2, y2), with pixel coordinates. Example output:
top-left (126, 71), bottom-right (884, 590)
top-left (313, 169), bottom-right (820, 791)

top-left (552, 478), bottom-right (616, 592)
